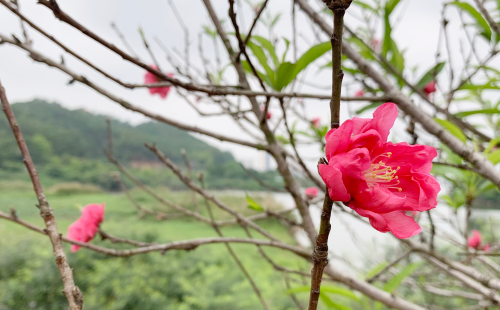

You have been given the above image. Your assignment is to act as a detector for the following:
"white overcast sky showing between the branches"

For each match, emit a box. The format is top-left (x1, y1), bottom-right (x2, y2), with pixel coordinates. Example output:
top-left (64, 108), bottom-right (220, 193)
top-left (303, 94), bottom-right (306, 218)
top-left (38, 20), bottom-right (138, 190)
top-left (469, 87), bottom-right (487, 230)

top-left (0, 0), bottom-right (478, 168)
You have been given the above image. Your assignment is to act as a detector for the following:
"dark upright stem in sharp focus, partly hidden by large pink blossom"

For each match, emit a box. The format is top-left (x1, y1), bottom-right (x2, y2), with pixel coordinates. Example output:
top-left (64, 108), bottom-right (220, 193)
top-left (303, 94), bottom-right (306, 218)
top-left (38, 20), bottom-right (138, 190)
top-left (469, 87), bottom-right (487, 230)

top-left (309, 0), bottom-right (352, 310)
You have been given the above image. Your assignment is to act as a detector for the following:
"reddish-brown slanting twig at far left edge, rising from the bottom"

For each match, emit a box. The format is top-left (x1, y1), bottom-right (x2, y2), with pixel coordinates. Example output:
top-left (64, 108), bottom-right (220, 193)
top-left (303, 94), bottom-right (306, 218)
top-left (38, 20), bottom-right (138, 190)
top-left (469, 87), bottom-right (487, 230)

top-left (0, 83), bottom-right (83, 310)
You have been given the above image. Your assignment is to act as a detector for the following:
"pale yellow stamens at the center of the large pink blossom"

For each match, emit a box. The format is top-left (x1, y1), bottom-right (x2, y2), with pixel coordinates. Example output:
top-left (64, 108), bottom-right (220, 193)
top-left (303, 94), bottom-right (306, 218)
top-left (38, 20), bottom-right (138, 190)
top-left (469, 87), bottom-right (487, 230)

top-left (364, 152), bottom-right (403, 192)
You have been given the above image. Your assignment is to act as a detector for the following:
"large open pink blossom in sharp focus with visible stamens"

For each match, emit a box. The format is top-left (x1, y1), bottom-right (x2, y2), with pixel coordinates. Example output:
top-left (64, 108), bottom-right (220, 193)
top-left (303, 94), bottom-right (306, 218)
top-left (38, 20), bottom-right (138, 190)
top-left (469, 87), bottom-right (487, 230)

top-left (319, 103), bottom-right (440, 239)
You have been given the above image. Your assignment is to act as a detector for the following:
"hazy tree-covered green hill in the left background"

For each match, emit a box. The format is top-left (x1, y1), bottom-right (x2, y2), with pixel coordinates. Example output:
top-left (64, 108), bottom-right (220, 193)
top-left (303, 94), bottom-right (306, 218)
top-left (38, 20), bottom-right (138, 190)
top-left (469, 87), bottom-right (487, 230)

top-left (0, 100), bottom-right (281, 190)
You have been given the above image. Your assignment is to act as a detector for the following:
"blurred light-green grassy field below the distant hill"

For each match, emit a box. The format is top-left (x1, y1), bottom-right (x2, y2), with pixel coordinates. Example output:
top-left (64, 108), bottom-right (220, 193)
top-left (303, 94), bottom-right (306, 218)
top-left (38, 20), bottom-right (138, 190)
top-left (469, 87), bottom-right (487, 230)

top-left (0, 182), bottom-right (308, 310)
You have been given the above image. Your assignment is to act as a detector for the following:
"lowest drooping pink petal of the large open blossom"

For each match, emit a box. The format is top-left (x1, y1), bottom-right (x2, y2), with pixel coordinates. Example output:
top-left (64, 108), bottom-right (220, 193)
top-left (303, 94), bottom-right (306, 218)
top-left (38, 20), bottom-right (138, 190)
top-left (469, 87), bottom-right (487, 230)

top-left (355, 209), bottom-right (422, 239)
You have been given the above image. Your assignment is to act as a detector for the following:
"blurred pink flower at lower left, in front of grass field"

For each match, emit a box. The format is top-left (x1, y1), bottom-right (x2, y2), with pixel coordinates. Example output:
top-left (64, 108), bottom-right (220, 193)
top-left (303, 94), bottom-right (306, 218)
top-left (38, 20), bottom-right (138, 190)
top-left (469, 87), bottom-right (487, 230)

top-left (68, 204), bottom-right (105, 252)
